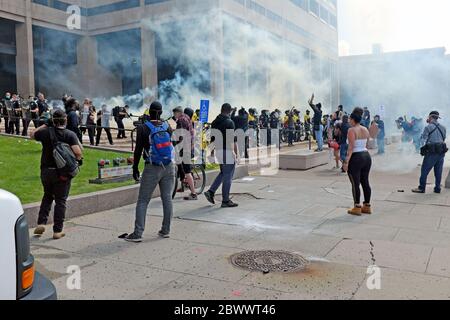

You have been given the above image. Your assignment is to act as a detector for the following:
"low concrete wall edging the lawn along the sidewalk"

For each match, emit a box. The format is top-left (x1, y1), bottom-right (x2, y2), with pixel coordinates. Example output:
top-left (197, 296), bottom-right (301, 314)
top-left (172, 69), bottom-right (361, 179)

top-left (23, 166), bottom-right (249, 228)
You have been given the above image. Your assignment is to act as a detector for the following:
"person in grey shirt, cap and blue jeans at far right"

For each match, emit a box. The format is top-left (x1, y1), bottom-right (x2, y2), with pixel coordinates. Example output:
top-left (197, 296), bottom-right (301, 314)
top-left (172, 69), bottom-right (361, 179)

top-left (412, 111), bottom-right (448, 193)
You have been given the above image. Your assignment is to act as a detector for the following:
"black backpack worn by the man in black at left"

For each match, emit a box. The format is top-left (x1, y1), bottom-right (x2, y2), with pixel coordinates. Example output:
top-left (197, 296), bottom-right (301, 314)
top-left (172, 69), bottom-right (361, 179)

top-left (49, 128), bottom-right (80, 178)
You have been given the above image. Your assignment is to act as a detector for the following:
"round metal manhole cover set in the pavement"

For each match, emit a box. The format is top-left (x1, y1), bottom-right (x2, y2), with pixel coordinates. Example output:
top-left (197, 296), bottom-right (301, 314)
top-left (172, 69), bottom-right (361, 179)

top-left (231, 250), bottom-right (309, 273)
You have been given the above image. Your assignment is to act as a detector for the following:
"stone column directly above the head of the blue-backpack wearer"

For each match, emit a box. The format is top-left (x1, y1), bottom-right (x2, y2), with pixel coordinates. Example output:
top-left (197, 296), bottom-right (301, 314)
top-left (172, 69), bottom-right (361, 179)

top-left (141, 24), bottom-right (158, 95)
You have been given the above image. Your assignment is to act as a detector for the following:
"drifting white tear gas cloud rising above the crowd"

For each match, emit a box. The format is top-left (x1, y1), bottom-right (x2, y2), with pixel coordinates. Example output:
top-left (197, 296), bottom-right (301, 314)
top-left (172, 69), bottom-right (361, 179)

top-left (32, 1), bottom-right (337, 116)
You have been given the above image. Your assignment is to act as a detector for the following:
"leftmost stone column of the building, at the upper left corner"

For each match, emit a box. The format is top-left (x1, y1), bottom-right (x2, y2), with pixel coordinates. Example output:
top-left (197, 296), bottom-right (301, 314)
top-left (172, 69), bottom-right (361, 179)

top-left (16, 0), bottom-right (36, 98)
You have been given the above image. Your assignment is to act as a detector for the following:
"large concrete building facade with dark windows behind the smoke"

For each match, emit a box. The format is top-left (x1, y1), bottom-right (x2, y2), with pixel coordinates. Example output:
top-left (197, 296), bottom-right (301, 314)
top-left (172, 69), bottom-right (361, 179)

top-left (0, 0), bottom-right (339, 109)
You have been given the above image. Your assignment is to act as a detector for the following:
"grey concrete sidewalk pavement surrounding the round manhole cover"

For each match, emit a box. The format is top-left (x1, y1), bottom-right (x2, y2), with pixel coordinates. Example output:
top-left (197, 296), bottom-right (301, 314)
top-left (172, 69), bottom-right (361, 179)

top-left (32, 147), bottom-right (450, 299)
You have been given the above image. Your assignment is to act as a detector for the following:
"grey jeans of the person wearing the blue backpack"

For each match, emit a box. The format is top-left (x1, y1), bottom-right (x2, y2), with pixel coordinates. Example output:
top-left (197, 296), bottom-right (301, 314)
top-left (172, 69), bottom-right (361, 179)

top-left (134, 163), bottom-right (175, 237)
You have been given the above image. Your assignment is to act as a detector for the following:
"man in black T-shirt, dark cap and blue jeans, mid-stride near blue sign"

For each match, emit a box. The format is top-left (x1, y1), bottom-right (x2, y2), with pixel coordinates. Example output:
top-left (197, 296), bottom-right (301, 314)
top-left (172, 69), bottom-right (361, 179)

top-left (205, 103), bottom-right (238, 208)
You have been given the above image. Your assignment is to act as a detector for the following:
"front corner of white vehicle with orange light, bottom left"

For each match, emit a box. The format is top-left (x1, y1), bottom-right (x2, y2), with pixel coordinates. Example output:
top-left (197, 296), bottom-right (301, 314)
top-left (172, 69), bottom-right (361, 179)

top-left (0, 190), bottom-right (56, 300)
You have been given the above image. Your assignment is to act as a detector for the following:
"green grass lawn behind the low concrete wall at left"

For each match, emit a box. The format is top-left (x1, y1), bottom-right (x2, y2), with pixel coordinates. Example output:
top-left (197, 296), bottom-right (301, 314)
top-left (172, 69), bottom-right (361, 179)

top-left (0, 136), bottom-right (143, 204)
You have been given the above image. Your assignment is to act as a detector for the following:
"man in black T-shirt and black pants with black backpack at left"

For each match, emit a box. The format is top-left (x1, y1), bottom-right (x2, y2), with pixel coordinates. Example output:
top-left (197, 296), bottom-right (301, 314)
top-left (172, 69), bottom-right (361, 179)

top-left (31, 110), bottom-right (83, 240)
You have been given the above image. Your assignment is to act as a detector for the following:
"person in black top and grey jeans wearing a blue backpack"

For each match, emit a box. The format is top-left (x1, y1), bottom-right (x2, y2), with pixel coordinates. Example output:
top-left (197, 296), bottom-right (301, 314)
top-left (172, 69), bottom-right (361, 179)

top-left (124, 101), bottom-right (175, 243)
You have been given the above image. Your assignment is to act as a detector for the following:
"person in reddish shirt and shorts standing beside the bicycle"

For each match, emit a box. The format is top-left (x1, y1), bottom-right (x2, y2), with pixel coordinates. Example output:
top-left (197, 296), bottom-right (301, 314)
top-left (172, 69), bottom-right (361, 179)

top-left (173, 107), bottom-right (198, 201)
